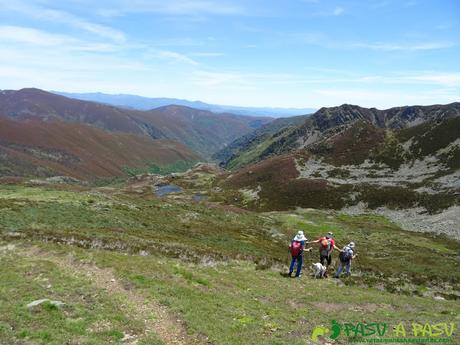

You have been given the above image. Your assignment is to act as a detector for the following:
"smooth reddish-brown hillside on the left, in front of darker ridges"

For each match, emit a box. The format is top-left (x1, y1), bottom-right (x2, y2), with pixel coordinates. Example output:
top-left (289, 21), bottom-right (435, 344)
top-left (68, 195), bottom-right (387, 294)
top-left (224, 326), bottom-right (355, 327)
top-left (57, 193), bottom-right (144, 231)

top-left (0, 117), bottom-right (199, 178)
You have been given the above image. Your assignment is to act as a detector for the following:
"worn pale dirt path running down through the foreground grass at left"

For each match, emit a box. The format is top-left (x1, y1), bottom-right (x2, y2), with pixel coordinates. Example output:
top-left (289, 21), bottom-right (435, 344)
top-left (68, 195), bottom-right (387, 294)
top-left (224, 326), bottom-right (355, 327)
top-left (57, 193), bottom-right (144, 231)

top-left (23, 247), bottom-right (207, 345)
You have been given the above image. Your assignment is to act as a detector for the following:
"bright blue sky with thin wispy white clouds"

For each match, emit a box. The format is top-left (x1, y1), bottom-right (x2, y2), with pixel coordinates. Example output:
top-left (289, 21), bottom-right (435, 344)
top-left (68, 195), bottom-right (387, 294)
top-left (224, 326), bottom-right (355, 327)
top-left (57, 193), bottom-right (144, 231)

top-left (0, 0), bottom-right (460, 109)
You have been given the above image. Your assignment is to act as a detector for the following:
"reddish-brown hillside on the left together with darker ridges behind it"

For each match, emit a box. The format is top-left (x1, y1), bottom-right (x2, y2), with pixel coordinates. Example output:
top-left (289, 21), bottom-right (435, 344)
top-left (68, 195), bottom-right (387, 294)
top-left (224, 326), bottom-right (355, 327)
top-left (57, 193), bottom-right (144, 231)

top-left (0, 89), bottom-right (272, 178)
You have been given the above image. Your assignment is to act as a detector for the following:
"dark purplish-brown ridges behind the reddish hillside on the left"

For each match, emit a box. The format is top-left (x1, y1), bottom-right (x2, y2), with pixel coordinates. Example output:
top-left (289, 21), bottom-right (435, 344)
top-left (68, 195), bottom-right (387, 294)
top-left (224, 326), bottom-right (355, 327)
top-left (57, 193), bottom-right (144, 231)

top-left (0, 89), bottom-right (272, 158)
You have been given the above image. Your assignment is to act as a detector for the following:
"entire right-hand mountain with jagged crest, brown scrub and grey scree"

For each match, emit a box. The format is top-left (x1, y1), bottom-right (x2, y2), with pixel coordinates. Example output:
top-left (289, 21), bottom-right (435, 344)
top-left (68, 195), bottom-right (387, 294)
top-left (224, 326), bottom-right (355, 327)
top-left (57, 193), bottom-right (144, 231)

top-left (214, 103), bottom-right (460, 237)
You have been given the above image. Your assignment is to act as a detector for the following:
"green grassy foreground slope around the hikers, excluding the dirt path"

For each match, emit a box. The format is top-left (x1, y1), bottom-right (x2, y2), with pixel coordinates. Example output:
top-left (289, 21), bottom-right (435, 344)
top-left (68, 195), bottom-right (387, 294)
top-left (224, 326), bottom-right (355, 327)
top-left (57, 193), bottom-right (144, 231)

top-left (0, 181), bottom-right (460, 344)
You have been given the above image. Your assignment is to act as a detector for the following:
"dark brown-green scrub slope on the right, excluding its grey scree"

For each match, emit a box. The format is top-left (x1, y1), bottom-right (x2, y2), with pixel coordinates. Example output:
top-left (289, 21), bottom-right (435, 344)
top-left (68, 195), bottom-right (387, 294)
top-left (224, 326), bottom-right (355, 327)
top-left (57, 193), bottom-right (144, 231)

top-left (223, 117), bottom-right (460, 213)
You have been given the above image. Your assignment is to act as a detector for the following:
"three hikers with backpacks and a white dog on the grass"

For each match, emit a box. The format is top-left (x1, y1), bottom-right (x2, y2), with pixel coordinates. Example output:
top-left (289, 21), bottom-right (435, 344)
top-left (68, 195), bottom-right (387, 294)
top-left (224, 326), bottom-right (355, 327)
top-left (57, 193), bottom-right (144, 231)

top-left (289, 231), bottom-right (358, 278)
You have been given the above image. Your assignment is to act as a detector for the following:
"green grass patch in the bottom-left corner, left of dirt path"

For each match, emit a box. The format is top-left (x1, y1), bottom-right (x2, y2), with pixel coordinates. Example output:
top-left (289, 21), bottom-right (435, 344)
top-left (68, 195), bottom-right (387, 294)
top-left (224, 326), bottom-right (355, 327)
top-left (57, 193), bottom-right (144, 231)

top-left (0, 246), bottom-right (161, 345)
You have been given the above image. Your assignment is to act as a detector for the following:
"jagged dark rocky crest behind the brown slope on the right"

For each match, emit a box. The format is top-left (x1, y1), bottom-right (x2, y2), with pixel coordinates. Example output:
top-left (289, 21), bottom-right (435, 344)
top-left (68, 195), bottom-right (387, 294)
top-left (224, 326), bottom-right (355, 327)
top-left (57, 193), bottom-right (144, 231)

top-left (219, 102), bottom-right (460, 167)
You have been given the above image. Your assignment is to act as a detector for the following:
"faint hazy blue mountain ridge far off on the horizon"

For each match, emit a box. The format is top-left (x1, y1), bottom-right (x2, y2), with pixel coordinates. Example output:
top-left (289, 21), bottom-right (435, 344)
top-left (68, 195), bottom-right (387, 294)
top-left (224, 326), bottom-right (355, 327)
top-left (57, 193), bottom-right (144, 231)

top-left (51, 91), bottom-right (316, 117)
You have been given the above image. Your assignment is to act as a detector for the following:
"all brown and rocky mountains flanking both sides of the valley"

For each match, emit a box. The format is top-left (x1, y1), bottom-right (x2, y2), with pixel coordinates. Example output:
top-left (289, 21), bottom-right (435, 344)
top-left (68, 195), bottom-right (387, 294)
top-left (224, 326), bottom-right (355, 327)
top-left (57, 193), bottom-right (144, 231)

top-left (0, 89), bottom-right (460, 236)
